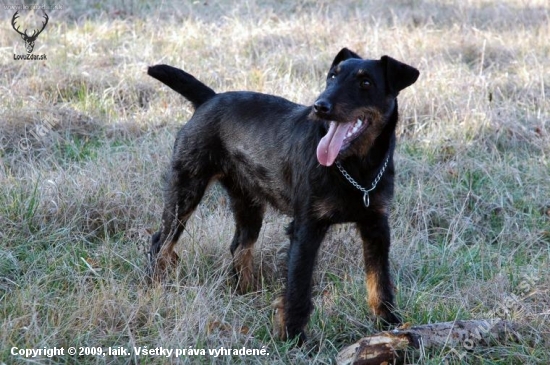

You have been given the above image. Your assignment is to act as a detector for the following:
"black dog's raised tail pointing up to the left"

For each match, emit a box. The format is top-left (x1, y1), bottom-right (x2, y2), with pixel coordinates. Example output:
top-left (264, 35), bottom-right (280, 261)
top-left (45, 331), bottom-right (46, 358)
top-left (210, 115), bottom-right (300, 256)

top-left (147, 65), bottom-right (216, 109)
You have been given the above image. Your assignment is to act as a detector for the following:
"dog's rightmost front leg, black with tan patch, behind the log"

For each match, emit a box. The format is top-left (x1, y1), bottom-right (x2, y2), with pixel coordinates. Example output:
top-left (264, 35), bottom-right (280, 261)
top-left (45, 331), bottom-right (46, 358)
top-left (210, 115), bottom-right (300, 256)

top-left (357, 214), bottom-right (401, 327)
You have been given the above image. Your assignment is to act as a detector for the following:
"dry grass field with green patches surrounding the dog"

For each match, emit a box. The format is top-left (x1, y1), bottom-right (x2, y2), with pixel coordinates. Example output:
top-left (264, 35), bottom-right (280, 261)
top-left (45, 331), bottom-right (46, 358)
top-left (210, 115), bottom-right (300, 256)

top-left (0, 0), bottom-right (550, 364)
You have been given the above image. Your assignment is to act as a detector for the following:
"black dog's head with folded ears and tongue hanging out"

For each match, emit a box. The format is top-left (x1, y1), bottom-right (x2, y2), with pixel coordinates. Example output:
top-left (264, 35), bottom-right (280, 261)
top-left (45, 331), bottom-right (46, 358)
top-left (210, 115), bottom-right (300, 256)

top-left (313, 48), bottom-right (419, 166)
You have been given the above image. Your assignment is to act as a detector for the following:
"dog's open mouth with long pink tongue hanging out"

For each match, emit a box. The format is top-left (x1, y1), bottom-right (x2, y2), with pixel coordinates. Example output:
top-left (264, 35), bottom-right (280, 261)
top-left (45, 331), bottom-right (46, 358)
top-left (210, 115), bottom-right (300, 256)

top-left (317, 117), bottom-right (370, 166)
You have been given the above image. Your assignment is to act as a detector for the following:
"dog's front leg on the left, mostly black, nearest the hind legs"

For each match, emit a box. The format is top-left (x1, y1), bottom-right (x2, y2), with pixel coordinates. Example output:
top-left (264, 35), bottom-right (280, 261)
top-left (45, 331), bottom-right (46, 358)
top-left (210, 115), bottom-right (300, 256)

top-left (275, 220), bottom-right (329, 345)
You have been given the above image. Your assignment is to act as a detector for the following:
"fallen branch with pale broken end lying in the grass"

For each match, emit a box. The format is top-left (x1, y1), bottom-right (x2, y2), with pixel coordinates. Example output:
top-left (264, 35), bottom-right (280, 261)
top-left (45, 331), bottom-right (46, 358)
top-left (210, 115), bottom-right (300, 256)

top-left (336, 319), bottom-right (519, 365)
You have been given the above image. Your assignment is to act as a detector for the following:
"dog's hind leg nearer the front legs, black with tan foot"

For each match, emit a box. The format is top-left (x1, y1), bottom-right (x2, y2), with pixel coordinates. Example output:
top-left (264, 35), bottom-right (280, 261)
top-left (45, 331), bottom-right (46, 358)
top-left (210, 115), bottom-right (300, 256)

top-left (221, 179), bottom-right (265, 294)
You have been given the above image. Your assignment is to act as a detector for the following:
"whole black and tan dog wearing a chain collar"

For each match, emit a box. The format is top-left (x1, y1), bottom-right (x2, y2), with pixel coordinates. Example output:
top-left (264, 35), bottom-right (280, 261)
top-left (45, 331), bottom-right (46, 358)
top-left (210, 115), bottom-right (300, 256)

top-left (148, 48), bottom-right (419, 342)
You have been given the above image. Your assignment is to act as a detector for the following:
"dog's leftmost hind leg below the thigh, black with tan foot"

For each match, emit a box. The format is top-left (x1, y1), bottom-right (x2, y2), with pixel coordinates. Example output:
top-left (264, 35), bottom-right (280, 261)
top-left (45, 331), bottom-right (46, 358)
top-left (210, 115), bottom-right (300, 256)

top-left (149, 167), bottom-right (211, 281)
